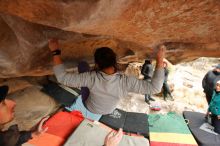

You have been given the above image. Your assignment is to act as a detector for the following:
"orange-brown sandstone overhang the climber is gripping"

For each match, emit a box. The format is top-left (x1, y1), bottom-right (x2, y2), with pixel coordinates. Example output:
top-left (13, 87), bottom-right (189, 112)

top-left (0, 0), bottom-right (220, 78)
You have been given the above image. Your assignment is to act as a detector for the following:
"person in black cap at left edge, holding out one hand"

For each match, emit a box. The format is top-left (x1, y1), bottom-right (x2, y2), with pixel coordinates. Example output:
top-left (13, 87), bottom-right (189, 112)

top-left (0, 86), bottom-right (49, 146)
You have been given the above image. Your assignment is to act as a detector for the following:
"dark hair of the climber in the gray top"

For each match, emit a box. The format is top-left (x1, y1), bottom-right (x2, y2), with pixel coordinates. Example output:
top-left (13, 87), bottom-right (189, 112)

top-left (94, 47), bottom-right (117, 70)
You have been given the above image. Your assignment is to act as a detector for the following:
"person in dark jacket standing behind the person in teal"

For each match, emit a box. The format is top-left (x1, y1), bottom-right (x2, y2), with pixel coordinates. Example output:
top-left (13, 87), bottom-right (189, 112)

top-left (202, 64), bottom-right (220, 104)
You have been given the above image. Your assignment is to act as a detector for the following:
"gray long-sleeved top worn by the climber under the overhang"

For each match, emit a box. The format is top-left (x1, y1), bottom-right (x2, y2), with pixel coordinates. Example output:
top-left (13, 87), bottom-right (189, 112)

top-left (54, 64), bottom-right (164, 114)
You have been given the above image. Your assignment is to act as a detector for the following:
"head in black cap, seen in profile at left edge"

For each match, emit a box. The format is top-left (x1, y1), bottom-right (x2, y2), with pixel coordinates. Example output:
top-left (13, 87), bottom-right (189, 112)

top-left (0, 86), bottom-right (16, 124)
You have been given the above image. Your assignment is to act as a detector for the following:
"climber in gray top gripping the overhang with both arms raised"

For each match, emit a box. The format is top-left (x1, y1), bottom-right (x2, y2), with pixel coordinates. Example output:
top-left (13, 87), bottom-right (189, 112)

top-left (49, 39), bottom-right (166, 120)
